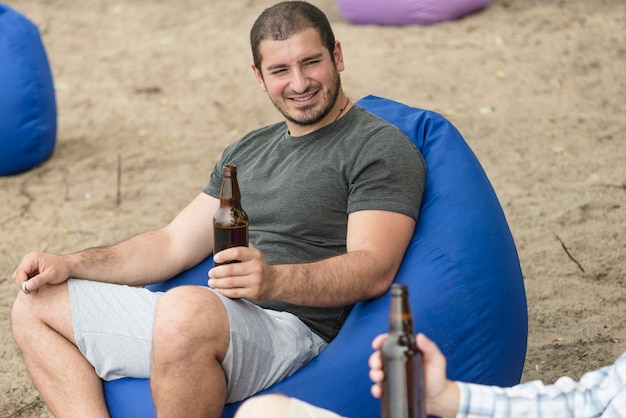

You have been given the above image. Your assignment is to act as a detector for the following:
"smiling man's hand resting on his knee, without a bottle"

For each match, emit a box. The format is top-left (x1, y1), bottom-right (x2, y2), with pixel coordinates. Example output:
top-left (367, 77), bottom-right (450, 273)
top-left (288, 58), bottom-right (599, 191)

top-left (11, 253), bottom-right (69, 293)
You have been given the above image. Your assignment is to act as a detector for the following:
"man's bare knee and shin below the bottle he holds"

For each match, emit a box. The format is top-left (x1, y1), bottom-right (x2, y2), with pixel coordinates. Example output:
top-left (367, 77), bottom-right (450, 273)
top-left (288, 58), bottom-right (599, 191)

top-left (150, 286), bottom-right (230, 418)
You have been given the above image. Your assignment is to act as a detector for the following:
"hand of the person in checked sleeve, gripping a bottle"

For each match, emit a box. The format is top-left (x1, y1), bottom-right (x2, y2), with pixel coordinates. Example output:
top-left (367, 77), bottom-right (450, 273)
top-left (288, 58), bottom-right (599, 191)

top-left (369, 333), bottom-right (459, 416)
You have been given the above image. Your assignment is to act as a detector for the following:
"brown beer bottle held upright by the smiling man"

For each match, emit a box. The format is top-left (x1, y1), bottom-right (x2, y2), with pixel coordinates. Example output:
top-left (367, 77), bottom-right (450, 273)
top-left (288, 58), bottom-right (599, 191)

top-left (213, 165), bottom-right (248, 266)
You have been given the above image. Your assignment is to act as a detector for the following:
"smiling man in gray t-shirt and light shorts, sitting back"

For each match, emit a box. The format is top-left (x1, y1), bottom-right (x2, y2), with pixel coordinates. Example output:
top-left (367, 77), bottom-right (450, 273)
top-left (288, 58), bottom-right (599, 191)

top-left (11, 2), bottom-right (426, 417)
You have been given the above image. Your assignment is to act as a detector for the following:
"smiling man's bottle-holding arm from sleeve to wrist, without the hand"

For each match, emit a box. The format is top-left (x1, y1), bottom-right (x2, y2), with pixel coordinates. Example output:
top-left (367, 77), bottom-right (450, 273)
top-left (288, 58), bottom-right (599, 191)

top-left (266, 210), bottom-right (415, 307)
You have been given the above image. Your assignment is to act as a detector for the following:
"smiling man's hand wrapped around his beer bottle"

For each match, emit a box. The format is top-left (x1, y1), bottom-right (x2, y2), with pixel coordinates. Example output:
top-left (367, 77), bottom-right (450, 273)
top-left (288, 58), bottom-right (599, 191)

top-left (208, 244), bottom-right (275, 302)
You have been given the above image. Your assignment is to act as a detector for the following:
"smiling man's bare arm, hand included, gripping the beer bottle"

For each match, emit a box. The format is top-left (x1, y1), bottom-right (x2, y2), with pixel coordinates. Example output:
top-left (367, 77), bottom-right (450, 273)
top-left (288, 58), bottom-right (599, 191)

top-left (209, 210), bottom-right (415, 306)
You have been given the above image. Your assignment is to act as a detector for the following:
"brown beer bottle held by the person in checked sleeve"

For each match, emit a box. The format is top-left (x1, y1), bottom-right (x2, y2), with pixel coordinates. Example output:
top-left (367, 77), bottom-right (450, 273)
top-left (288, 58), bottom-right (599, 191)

top-left (380, 284), bottom-right (426, 418)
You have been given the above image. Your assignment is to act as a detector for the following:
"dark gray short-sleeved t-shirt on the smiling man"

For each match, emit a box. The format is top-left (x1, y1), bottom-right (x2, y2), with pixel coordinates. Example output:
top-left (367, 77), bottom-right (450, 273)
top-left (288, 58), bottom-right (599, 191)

top-left (204, 105), bottom-right (426, 341)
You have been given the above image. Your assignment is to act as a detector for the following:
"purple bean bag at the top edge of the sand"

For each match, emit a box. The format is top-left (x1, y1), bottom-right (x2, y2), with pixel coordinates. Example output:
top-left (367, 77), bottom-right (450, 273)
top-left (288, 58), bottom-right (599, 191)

top-left (337, 0), bottom-right (490, 26)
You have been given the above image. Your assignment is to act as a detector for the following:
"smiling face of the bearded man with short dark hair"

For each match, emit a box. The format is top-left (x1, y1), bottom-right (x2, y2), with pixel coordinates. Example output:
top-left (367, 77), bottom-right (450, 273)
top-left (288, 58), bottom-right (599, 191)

top-left (253, 29), bottom-right (344, 135)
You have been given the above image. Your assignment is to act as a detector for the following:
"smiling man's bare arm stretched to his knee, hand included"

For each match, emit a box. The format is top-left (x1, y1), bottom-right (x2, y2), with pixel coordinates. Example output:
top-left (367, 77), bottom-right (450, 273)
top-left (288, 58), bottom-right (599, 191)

top-left (13, 193), bottom-right (219, 291)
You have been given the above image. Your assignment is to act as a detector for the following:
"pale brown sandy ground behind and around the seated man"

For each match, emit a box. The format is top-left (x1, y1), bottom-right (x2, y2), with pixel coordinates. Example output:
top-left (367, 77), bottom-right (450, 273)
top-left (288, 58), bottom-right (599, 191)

top-left (0, 0), bottom-right (626, 417)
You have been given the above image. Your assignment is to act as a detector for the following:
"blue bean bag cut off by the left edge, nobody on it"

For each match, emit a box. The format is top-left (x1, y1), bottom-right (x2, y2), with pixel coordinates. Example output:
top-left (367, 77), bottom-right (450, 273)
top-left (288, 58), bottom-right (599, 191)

top-left (0, 4), bottom-right (57, 176)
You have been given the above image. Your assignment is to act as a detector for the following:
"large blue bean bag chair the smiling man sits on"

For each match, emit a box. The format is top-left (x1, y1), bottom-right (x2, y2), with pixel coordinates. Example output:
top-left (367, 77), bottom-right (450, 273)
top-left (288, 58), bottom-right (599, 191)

top-left (105, 96), bottom-right (528, 418)
